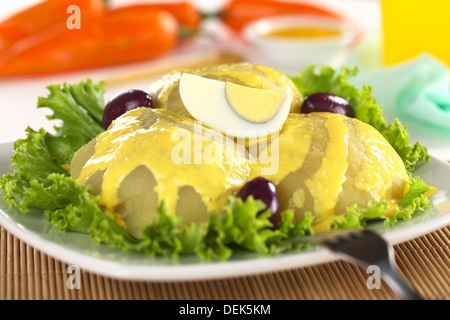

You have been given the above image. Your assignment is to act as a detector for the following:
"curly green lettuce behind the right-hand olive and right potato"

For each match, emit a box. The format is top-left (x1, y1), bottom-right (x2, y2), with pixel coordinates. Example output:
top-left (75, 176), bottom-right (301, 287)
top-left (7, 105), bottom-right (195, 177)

top-left (291, 65), bottom-right (430, 172)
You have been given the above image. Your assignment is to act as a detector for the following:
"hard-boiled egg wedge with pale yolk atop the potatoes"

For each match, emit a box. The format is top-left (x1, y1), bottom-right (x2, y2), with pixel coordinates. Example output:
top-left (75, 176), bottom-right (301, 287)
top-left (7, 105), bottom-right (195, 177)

top-left (179, 73), bottom-right (292, 138)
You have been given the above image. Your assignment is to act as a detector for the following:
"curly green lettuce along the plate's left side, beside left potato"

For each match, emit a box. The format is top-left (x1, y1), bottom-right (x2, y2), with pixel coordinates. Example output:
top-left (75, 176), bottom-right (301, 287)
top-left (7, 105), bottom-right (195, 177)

top-left (0, 79), bottom-right (142, 250)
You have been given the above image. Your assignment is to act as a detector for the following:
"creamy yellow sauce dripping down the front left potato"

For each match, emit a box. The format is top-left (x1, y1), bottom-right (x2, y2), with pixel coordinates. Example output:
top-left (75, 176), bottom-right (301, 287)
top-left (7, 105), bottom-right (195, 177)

top-left (78, 108), bottom-right (250, 228)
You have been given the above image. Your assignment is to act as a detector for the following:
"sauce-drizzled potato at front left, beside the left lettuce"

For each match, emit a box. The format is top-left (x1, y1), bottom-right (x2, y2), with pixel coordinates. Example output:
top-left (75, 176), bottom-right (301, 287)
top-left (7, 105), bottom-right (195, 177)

top-left (71, 108), bottom-right (250, 237)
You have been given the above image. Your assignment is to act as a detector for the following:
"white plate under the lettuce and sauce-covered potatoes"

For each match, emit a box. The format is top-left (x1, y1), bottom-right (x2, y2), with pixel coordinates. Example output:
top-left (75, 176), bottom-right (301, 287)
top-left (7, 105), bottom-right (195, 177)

top-left (0, 143), bottom-right (450, 281)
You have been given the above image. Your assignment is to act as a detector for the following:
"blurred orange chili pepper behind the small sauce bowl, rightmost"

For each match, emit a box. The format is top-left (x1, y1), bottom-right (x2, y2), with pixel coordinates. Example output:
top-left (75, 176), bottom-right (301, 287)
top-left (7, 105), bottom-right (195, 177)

top-left (220, 0), bottom-right (343, 32)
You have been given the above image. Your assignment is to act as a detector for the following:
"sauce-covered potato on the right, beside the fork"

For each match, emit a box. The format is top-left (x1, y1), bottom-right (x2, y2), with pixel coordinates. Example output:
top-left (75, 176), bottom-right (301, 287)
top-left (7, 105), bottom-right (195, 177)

top-left (251, 112), bottom-right (409, 231)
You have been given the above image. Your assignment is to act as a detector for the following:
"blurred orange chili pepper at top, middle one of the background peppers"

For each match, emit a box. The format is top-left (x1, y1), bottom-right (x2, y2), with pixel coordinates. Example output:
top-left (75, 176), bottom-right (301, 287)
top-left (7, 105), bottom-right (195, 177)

top-left (111, 1), bottom-right (202, 35)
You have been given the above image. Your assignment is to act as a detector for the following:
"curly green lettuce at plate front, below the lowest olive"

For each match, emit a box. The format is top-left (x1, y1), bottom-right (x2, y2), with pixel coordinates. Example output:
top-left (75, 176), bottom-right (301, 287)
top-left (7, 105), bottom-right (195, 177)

top-left (135, 196), bottom-right (313, 260)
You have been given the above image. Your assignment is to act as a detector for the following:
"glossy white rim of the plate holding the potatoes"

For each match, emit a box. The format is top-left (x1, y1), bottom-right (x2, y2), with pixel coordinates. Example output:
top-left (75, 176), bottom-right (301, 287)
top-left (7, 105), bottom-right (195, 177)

top-left (0, 142), bottom-right (450, 281)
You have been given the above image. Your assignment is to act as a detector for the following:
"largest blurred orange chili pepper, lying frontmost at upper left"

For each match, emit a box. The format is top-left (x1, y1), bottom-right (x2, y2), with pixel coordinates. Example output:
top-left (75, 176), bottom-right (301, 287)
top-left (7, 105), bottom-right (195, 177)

top-left (0, 9), bottom-right (178, 75)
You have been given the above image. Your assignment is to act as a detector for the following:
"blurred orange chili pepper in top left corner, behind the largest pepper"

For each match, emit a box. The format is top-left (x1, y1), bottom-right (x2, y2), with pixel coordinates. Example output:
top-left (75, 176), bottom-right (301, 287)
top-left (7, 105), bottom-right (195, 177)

top-left (0, 0), bottom-right (106, 53)
